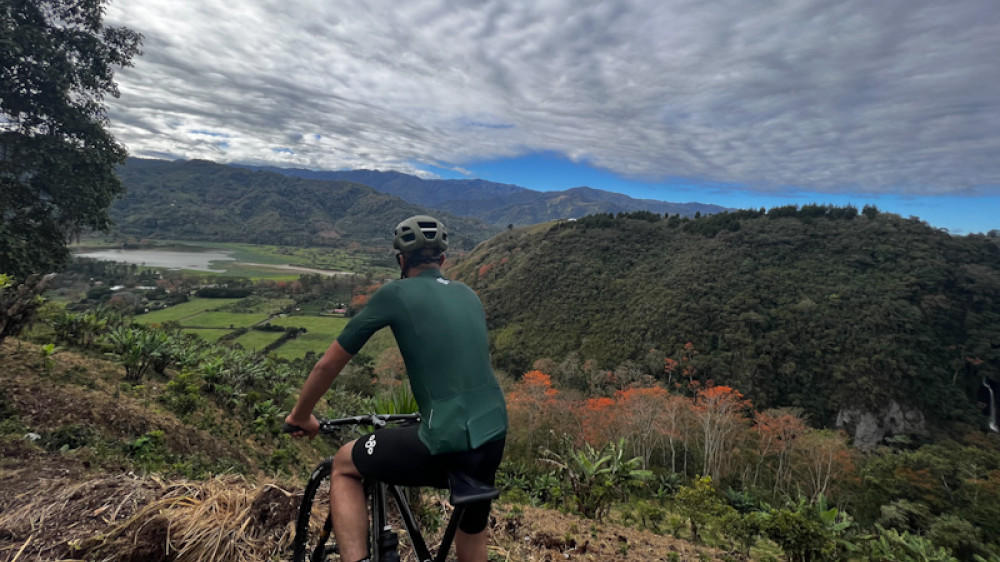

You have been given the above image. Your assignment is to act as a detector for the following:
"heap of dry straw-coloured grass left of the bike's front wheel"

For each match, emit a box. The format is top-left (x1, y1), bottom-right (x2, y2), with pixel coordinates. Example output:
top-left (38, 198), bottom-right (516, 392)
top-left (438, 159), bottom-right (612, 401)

top-left (0, 476), bottom-right (301, 562)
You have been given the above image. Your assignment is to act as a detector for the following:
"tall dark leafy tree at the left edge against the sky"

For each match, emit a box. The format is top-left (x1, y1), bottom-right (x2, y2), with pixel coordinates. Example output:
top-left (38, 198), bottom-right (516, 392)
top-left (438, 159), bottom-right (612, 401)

top-left (0, 0), bottom-right (142, 279)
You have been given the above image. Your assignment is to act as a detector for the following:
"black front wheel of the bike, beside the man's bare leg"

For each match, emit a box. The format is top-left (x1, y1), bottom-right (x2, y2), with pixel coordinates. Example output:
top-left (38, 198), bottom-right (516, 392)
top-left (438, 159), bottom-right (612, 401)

top-left (292, 458), bottom-right (336, 562)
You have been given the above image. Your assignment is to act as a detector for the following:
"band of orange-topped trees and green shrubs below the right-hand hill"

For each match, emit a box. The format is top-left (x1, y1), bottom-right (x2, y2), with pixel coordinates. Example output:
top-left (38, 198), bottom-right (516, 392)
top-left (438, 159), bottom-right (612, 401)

top-left (501, 364), bottom-right (1000, 560)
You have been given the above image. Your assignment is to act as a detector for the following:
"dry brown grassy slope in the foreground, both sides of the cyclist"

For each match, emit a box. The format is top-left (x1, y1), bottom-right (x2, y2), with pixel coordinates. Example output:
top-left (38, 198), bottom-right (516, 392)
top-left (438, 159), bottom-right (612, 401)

top-left (0, 340), bottom-right (736, 562)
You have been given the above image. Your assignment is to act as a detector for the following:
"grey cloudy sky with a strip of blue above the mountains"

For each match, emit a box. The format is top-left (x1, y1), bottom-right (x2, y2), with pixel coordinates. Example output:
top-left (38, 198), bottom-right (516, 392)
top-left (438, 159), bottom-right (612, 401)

top-left (106, 0), bottom-right (1000, 233)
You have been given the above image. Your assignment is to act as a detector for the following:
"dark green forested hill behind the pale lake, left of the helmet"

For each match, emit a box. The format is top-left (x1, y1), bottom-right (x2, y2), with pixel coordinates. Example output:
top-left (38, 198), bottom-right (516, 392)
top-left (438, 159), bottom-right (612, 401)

top-left (110, 158), bottom-right (499, 250)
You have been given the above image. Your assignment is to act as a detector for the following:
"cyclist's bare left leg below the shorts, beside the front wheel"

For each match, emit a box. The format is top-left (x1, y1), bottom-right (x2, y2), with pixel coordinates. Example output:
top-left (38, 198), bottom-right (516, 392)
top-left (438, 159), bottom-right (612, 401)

top-left (330, 441), bottom-right (368, 562)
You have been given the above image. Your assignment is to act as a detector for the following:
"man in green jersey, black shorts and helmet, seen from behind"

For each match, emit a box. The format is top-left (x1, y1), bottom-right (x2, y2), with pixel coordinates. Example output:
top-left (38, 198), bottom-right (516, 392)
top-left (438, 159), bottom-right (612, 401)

top-left (285, 215), bottom-right (507, 562)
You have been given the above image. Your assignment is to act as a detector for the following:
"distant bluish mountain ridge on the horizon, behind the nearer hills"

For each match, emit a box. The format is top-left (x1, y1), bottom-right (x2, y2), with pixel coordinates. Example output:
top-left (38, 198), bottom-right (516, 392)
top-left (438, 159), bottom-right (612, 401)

top-left (238, 163), bottom-right (726, 227)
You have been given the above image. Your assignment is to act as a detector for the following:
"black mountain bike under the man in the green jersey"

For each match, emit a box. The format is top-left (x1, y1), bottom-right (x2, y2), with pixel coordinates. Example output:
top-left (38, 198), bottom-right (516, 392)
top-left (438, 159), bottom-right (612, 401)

top-left (285, 414), bottom-right (500, 562)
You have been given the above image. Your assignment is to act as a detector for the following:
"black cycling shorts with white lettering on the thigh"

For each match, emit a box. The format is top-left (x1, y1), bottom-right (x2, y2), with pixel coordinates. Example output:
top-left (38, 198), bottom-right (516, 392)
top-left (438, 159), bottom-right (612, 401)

top-left (351, 424), bottom-right (505, 535)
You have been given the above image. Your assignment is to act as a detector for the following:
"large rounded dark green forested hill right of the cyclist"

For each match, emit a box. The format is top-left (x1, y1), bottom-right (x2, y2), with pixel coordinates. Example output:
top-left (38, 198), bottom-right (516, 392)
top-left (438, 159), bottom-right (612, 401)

top-left (452, 206), bottom-right (1000, 424)
